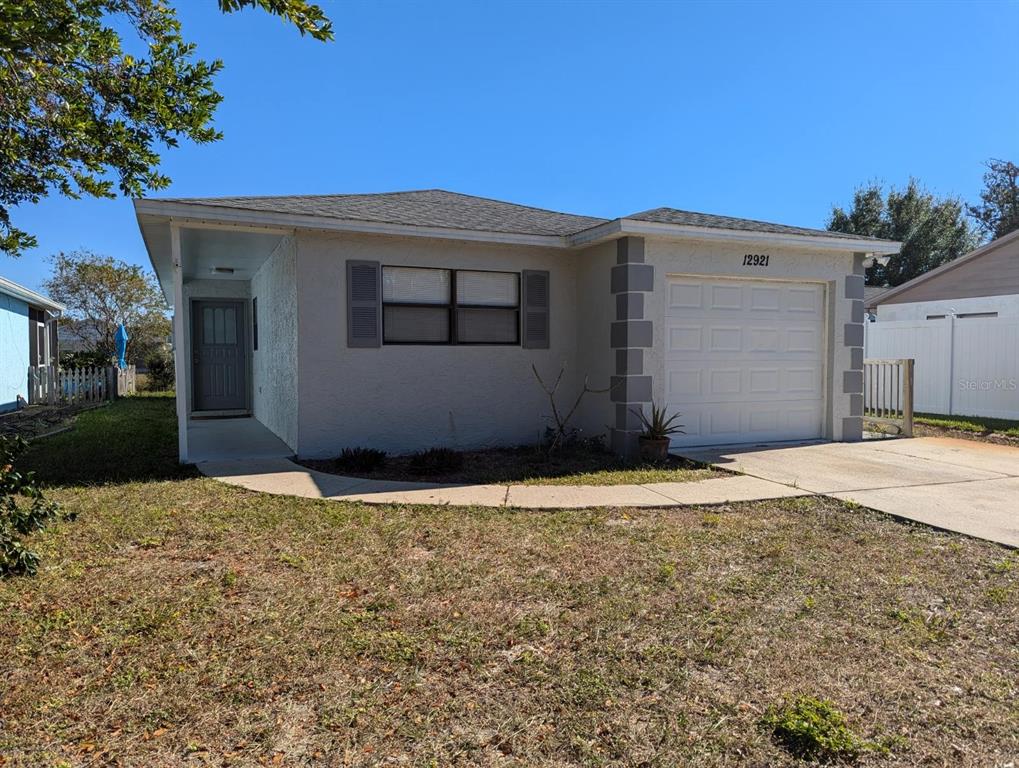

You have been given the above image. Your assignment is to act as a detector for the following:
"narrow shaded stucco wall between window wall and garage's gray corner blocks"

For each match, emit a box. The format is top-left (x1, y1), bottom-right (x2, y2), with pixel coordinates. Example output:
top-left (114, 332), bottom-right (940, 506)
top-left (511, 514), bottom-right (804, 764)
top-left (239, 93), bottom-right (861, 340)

top-left (573, 240), bottom-right (616, 446)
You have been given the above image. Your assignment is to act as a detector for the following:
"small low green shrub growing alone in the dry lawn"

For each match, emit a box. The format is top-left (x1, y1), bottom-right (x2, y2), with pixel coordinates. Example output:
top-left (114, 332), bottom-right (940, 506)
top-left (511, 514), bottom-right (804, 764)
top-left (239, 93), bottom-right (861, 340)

top-left (763, 696), bottom-right (875, 762)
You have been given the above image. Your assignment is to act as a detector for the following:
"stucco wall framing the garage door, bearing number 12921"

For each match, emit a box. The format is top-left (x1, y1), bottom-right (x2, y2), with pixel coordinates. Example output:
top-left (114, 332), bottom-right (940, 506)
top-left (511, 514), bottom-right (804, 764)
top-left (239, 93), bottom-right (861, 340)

top-left (644, 237), bottom-right (853, 440)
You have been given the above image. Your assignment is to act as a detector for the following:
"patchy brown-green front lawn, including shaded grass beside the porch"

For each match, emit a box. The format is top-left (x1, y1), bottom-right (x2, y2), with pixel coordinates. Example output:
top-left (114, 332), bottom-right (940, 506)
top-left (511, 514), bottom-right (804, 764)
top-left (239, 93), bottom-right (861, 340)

top-left (0, 391), bottom-right (1019, 768)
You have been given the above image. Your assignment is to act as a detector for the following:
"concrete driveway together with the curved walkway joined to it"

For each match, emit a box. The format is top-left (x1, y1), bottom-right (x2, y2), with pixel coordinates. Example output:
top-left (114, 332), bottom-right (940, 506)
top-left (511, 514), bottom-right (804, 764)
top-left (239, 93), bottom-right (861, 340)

top-left (198, 438), bottom-right (1019, 547)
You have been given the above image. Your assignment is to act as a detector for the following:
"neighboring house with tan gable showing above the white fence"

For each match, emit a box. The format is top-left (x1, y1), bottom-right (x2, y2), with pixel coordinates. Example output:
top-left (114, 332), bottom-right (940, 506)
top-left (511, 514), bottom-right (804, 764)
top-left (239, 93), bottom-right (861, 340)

top-left (873, 230), bottom-right (1019, 321)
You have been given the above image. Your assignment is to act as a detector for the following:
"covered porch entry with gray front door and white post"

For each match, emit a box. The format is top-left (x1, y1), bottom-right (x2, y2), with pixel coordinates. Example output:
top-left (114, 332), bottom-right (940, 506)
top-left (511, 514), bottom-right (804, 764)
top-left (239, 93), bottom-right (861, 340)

top-left (136, 201), bottom-right (298, 463)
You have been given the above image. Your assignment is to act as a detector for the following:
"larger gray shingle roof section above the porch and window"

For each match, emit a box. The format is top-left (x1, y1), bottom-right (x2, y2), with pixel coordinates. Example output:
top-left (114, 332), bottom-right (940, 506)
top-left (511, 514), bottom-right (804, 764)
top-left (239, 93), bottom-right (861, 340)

top-left (157, 189), bottom-right (605, 235)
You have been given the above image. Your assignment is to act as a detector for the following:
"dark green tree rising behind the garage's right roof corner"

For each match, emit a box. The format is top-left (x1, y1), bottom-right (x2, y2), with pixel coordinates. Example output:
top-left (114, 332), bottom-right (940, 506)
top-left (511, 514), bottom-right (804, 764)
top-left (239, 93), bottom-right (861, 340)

top-left (827, 179), bottom-right (978, 287)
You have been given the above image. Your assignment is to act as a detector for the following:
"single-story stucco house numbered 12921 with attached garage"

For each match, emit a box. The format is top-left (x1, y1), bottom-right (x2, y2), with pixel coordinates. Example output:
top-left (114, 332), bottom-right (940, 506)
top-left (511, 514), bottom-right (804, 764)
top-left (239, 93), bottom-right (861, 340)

top-left (135, 189), bottom-right (899, 461)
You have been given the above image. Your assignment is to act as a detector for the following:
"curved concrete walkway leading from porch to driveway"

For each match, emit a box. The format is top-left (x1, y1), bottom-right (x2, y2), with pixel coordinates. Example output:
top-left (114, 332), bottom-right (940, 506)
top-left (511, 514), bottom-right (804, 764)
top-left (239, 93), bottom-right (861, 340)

top-left (198, 457), bottom-right (809, 509)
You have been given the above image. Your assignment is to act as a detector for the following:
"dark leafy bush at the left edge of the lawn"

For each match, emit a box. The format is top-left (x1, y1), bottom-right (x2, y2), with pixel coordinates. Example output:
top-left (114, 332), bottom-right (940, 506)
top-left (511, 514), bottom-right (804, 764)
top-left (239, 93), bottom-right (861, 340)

top-left (0, 437), bottom-right (68, 575)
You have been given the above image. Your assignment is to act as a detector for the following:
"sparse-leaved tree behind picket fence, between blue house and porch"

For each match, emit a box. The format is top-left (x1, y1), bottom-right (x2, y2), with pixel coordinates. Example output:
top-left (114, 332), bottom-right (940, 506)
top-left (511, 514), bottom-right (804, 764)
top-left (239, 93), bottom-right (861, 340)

top-left (45, 251), bottom-right (170, 363)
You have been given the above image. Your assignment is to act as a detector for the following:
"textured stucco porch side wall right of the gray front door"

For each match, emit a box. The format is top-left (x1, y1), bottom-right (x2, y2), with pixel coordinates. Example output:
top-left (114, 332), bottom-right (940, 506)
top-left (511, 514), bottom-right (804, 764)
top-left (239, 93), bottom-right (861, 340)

top-left (251, 237), bottom-right (297, 450)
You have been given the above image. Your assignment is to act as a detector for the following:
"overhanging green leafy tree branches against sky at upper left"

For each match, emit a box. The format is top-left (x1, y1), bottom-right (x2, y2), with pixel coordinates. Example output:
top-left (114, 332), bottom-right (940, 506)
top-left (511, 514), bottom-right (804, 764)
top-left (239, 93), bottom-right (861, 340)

top-left (0, 0), bottom-right (332, 256)
